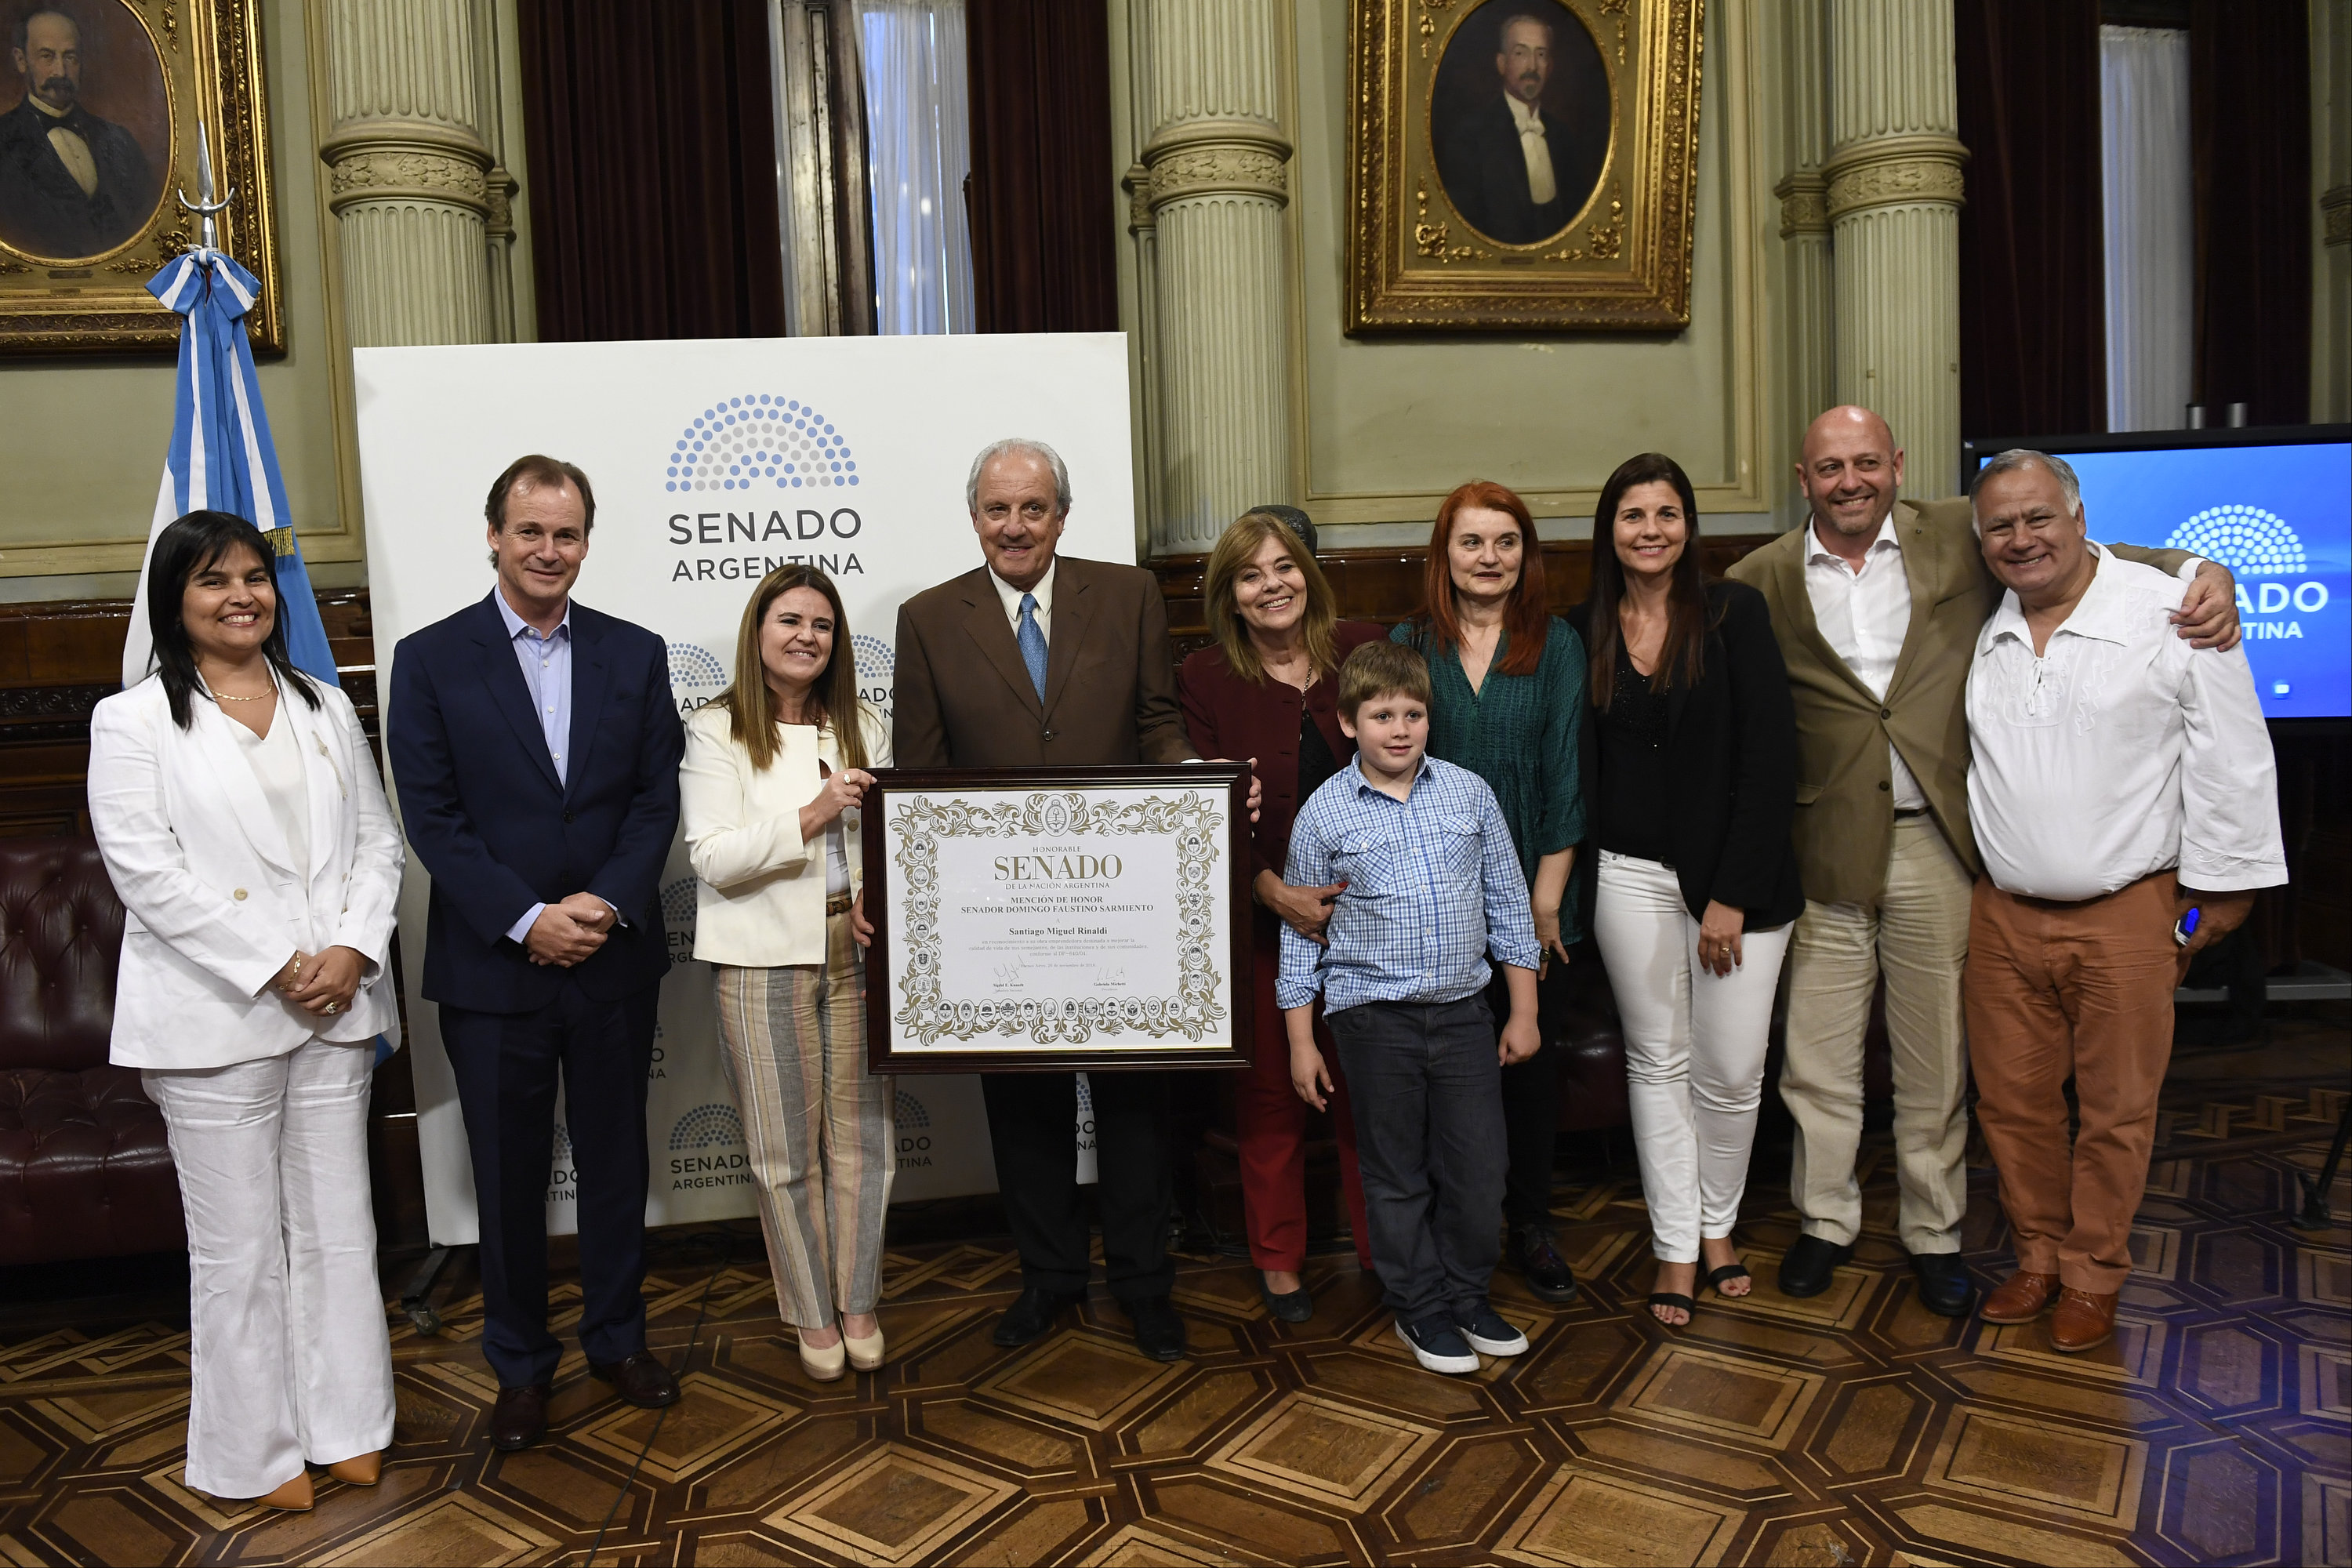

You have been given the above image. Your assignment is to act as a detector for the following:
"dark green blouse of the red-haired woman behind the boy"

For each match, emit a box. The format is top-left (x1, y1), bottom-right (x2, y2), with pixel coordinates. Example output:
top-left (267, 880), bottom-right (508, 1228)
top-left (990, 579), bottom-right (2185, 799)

top-left (1388, 616), bottom-right (1585, 942)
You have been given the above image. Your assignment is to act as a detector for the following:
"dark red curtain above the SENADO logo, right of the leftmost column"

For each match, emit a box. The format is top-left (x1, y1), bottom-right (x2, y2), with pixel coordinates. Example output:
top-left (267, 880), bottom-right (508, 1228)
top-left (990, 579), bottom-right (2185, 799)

top-left (517, 0), bottom-right (786, 341)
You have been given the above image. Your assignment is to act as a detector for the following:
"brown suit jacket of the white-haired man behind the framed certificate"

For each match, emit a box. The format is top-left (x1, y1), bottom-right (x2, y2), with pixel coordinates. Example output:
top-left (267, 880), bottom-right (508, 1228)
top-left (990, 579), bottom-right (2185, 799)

top-left (891, 555), bottom-right (1197, 769)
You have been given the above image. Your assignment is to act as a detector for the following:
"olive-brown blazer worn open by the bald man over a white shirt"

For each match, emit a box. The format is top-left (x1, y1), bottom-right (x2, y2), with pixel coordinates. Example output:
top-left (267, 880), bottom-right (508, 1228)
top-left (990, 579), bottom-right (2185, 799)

top-left (1729, 496), bottom-right (2190, 902)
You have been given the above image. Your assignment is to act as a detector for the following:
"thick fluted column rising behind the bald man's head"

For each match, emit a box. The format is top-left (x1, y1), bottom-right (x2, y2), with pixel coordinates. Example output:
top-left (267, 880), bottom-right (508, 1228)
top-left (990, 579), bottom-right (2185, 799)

top-left (1823, 0), bottom-right (1969, 499)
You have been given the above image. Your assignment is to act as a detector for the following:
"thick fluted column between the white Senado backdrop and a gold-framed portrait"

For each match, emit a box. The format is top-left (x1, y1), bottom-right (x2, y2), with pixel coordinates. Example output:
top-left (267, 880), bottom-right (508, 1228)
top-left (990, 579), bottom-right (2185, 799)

top-left (1134, 0), bottom-right (1294, 555)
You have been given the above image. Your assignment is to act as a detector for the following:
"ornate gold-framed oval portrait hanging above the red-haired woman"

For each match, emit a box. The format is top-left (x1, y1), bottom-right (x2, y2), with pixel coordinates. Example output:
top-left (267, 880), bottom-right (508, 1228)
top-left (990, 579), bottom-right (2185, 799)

top-left (1348, 0), bottom-right (1705, 334)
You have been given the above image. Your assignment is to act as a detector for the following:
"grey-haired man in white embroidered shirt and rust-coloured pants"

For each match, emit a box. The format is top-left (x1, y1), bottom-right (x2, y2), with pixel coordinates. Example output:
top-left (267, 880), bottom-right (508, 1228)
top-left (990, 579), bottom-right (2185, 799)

top-left (1964, 452), bottom-right (2286, 1352)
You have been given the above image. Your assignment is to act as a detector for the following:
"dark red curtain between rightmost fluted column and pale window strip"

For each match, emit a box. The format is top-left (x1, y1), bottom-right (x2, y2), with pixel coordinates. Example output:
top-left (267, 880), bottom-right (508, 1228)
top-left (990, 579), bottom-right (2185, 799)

top-left (1952, 0), bottom-right (2107, 435)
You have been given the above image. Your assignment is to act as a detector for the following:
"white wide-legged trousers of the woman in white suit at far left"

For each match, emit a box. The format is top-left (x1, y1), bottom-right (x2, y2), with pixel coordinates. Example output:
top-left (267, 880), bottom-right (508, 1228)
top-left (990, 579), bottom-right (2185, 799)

top-left (139, 1039), bottom-right (393, 1497)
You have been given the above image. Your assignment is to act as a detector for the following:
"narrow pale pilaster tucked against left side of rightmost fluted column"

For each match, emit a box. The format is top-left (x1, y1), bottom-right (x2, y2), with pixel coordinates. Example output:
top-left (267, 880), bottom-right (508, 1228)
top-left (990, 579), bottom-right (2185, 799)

top-left (1771, 0), bottom-right (1837, 482)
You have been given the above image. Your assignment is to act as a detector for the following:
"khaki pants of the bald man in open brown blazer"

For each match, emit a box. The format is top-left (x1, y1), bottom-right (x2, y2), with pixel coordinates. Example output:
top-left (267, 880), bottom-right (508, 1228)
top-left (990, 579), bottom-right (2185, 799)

top-left (1780, 815), bottom-right (1969, 1253)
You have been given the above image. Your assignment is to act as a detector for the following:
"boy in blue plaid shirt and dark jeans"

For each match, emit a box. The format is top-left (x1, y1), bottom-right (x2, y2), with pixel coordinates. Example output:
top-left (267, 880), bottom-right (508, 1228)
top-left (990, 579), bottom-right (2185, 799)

top-left (1275, 642), bottom-right (1538, 1373)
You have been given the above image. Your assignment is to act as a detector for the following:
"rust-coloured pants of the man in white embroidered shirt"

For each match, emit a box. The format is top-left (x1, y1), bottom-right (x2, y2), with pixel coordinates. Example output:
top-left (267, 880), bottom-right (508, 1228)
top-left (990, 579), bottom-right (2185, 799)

top-left (1964, 872), bottom-right (2180, 1295)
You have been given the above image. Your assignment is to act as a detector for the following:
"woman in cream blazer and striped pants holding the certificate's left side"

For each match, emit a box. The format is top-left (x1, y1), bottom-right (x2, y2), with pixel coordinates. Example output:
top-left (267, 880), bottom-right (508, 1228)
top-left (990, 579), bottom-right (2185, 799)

top-left (680, 567), bottom-right (896, 1382)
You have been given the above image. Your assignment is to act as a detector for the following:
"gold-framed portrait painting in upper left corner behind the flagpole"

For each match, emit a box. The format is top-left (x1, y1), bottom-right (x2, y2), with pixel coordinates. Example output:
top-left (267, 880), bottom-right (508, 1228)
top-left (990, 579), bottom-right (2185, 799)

top-left (0, 0), bottom-right (285, 355)
